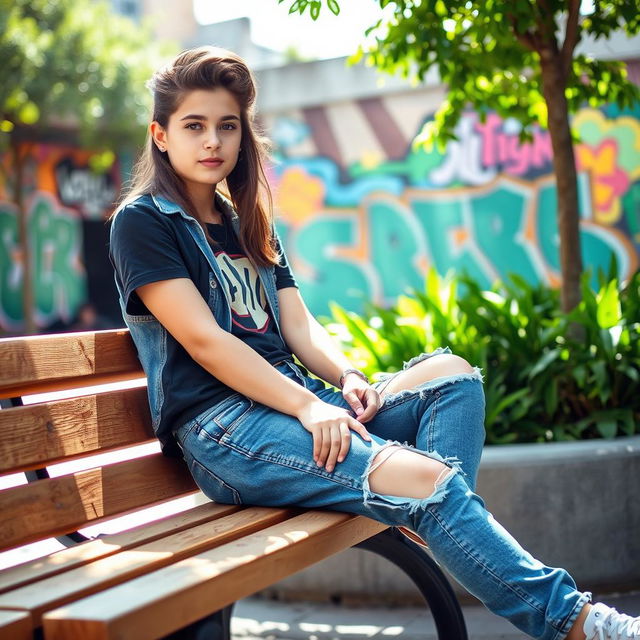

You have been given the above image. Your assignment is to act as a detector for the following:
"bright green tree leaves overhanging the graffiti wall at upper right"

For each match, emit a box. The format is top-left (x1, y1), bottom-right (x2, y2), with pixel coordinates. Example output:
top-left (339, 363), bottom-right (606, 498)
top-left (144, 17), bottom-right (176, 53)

top-left (279, 0), bottom-right (640, 147)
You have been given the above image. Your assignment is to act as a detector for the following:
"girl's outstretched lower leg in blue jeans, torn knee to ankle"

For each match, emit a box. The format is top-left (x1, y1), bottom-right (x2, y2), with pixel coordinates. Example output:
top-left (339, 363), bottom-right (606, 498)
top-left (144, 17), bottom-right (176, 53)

top-left (365, 446), bottom-right (589, 640)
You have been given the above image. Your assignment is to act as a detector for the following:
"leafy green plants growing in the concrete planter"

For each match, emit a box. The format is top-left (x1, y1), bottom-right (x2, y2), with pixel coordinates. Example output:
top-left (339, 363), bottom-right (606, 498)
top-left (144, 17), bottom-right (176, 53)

top-left (327, 269), bottom-right (640, 443)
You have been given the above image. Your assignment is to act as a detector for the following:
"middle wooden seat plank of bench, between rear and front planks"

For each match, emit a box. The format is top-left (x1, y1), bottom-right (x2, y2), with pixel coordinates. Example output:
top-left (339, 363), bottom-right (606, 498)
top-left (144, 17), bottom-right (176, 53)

top-left (0, 507), bottom-right (295, 626)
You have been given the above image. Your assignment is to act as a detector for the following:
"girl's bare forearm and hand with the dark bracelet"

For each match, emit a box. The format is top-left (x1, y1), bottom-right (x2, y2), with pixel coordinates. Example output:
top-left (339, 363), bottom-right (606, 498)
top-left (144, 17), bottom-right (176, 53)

top-left (278, 287), bottom-right (380, 422)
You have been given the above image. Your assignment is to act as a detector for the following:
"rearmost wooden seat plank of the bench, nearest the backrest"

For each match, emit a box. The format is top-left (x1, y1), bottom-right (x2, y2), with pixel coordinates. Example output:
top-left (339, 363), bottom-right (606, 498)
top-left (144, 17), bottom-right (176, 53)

top-left (0, 502), bottom-right (242, 594)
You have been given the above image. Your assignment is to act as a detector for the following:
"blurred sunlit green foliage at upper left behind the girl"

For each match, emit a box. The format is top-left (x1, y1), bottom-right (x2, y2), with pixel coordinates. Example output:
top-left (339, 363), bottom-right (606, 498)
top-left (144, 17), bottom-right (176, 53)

top-left (0, 0), bottom-right (174, 149)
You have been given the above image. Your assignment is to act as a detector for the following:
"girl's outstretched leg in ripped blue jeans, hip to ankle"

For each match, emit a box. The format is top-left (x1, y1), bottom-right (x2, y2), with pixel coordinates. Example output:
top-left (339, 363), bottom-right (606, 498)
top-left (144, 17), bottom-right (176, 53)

top-left (177, 362), bottom-right (589, 640)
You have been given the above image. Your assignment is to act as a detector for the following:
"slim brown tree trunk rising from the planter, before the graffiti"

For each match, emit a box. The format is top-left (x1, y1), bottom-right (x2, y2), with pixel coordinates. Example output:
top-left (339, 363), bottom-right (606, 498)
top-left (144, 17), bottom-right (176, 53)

top-left (541, 56), bottom-right (582, 312)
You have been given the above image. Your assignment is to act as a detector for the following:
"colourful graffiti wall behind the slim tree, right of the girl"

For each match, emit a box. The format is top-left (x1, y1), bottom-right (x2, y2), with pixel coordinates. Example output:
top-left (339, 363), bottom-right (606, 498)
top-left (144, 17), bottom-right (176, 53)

top-left (266, 91), bottom-right (640, 314)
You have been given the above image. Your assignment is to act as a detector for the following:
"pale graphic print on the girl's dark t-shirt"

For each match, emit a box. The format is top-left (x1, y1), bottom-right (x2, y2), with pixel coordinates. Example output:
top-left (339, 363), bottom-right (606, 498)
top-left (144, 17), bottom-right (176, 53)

top-left (215, 251), bottom-right (269, 333)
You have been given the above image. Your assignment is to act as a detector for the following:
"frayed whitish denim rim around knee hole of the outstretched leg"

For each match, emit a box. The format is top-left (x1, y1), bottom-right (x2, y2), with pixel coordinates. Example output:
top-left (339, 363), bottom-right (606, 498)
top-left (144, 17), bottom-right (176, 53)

top-left (362, 441), bottom-right (463, 513)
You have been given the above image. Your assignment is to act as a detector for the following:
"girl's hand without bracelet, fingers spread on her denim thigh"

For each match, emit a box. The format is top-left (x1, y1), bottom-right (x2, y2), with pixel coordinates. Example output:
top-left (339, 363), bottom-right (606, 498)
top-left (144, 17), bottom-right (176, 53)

top-left (297, 400), bottom-right (371, 472)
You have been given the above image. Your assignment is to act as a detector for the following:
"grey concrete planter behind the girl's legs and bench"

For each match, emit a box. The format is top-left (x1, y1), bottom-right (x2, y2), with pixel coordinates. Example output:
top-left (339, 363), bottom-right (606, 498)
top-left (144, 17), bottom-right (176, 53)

top-left (265, 436), bottom-right (640, 603)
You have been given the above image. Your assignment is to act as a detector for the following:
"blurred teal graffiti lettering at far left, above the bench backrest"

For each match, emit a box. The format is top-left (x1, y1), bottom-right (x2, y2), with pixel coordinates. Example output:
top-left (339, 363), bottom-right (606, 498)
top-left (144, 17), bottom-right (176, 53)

top-left (0, 192), bottom-right (86, 330)
